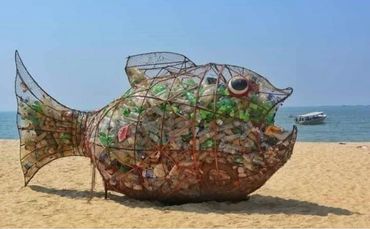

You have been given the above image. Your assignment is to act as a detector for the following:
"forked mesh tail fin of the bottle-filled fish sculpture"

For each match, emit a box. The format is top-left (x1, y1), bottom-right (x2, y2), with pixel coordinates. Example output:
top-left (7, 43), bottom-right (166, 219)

top-left (15, 51), bottom-right (90, 185)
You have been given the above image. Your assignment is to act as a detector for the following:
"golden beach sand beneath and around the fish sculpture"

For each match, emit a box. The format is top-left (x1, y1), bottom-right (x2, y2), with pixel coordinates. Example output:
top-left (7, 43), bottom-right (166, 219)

top-left (0, 140), bottom-right (370, 227)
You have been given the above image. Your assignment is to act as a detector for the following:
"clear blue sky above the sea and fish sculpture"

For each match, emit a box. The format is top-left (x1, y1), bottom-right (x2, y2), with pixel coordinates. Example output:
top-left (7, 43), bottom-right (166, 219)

top-left (0, 0), bottom-right (370, 111)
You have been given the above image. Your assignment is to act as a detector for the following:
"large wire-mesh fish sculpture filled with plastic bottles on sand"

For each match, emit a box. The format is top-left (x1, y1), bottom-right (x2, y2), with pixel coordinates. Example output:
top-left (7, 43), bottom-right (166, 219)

top-left (15, 52), bottom-right (297, 203)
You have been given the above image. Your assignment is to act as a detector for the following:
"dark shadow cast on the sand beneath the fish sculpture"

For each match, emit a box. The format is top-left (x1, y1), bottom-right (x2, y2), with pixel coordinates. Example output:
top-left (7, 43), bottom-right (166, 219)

top-left (29, 185), bottom-right (355, 216)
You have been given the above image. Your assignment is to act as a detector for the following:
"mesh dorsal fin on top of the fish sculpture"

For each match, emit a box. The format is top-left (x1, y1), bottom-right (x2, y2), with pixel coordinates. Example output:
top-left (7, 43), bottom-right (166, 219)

top-left (125, 52), bottom-right (196, 87)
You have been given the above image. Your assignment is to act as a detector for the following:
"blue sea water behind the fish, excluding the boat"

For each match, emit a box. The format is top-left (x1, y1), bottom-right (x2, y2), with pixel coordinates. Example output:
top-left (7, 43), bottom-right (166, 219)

top-left (0, 106), bottom-right (370, 142)
